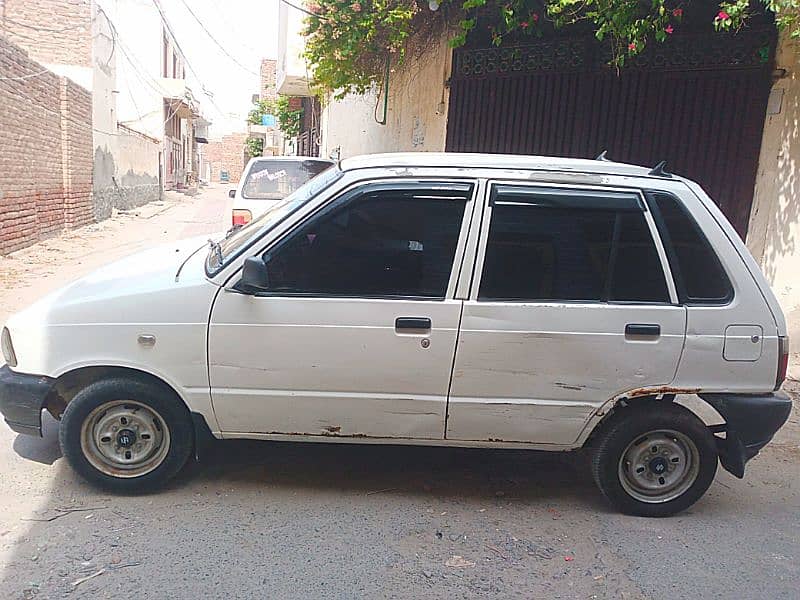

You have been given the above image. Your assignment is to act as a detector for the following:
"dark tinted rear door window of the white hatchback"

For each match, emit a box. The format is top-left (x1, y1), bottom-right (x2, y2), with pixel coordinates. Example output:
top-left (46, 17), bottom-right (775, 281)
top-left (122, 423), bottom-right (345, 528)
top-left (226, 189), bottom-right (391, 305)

top-left (478, 186), bottom-right (669, 302)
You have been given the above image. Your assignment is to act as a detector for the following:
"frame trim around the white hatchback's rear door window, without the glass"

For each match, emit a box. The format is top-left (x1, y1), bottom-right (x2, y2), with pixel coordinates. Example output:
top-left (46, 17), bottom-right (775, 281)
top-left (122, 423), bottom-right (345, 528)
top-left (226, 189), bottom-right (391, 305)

top-left (469, 179), bottom-right (680, 306)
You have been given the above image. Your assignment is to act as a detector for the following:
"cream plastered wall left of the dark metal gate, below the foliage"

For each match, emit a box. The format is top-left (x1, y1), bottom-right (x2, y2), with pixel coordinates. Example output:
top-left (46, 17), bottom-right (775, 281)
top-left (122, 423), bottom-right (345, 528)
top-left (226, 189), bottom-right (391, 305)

top-left (320, 35), bottom-right (452, 158)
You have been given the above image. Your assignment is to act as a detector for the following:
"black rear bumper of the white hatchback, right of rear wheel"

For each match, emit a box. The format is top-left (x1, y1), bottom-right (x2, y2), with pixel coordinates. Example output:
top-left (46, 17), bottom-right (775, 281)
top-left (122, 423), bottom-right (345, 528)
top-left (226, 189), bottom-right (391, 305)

top-left (700, 391), bottom-right (792, 479)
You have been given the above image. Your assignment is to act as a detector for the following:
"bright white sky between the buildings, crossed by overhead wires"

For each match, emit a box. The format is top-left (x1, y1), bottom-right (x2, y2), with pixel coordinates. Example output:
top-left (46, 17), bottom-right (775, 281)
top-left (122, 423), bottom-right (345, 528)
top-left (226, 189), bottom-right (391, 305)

top-left (161, 0), bottom-right (280, 137)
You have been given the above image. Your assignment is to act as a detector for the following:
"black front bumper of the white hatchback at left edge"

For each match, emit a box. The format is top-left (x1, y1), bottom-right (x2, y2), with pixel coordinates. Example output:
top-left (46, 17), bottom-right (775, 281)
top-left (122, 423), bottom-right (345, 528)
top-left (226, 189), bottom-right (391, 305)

top-left (0, 365), bottom-right (55, 436)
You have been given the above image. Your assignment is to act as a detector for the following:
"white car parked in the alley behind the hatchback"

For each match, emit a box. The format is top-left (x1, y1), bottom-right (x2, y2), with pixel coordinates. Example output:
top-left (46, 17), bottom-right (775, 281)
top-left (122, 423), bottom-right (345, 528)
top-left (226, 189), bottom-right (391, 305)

top-left (228, 156), bottom-right (333, 227)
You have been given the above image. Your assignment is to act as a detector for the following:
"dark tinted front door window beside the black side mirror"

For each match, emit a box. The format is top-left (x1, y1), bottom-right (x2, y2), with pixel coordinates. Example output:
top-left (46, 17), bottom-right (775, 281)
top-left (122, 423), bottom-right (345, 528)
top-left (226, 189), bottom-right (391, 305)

top-left (264, 184), bottom-right (471, 298)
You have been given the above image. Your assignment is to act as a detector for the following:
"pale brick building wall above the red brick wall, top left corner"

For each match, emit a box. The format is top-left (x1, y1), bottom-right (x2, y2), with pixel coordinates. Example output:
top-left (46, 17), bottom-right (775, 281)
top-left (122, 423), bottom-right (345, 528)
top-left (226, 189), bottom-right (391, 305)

top-left (0, 0), bottom-right (92, 67)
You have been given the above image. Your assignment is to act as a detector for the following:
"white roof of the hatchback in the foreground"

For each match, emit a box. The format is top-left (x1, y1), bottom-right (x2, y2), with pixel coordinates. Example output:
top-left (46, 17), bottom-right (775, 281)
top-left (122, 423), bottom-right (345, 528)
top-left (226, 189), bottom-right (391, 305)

top-left (340, 152), bottom-right (664, 177)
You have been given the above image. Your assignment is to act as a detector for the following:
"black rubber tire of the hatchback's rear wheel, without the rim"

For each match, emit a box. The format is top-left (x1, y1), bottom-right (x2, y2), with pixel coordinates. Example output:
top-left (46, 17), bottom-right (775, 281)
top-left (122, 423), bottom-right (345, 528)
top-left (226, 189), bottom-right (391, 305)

top-left (591, 402), bottom-right (717, 517)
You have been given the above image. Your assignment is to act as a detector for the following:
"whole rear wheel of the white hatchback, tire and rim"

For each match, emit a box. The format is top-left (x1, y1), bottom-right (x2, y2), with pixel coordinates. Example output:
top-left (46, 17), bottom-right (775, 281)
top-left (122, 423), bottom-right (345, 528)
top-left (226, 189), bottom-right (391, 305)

top-left (592, 403), bottom-right (717, 517)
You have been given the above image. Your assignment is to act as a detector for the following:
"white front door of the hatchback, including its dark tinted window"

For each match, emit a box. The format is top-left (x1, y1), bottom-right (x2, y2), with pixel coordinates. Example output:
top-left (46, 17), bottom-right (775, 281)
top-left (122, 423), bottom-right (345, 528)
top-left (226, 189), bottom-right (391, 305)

top-left (209, 180), bottom-right (473, 439)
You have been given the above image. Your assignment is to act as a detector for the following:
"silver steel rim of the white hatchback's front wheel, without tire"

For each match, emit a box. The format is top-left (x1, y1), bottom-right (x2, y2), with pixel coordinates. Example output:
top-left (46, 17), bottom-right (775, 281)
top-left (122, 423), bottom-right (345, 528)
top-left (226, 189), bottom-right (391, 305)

top-left (81, 400), bottom-right (170, 478)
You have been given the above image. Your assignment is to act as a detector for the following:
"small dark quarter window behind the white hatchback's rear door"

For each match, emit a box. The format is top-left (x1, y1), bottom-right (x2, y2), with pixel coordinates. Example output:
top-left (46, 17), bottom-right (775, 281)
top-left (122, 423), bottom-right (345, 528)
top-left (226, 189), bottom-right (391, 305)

top-left (646, 192), bottom-right (733, 304)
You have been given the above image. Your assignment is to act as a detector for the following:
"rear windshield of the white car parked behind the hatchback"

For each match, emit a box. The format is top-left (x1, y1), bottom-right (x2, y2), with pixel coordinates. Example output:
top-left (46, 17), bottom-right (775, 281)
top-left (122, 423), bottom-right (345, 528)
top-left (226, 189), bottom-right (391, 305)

top-left (242, 159), bottom-right (331, 200)
